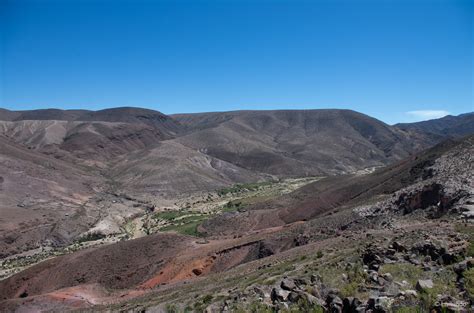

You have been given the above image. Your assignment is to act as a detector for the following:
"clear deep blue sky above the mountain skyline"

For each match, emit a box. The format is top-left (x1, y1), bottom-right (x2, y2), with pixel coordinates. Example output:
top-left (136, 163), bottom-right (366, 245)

top-left (0, 0), bottom-right (474, 123)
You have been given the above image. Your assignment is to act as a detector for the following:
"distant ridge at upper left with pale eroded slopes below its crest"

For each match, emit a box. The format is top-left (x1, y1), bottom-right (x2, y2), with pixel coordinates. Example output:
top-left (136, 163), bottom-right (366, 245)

top-left (0, 108), bottom-right (182, 168)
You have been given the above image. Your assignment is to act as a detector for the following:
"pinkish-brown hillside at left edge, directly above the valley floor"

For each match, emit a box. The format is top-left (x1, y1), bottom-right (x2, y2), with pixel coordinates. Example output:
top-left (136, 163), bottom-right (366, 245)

top-left (0, 136), bottom-right (104, 257)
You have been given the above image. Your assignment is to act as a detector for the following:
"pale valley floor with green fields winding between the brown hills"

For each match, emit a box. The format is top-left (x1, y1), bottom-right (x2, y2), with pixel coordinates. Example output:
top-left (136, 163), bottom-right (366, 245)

top-left (0, 177), bottom-right (321, 280)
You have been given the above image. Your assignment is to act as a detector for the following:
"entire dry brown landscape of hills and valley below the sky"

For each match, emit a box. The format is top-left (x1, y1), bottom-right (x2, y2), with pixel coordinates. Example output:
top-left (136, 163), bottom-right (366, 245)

top-left (0, 108), bottom-right (474, 312)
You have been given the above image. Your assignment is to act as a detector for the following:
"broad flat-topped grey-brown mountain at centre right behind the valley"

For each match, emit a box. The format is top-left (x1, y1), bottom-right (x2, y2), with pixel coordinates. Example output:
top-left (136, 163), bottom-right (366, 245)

top-left (173, 110), bottom-right (430, 176)
